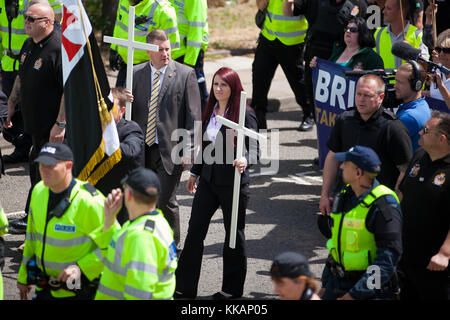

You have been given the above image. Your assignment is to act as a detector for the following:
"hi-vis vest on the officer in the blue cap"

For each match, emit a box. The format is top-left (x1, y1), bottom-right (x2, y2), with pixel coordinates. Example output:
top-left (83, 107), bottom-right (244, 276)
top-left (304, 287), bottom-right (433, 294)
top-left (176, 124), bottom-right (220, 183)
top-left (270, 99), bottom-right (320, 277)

top-left (327, 185), bottom-right (398, 271)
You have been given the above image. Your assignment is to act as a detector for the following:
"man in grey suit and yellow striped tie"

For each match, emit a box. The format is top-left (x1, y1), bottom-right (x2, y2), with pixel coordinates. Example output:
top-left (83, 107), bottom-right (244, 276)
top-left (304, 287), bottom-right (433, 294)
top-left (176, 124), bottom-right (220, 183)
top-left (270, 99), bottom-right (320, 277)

top-left (131, 29), bottom-right (201, 245)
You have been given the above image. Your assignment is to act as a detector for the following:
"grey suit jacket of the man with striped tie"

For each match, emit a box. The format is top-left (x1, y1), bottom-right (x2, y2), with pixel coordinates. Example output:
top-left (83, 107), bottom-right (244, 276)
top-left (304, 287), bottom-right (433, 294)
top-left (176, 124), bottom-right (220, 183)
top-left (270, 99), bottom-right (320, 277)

top-left (131, 60), bottom-right (201, 174)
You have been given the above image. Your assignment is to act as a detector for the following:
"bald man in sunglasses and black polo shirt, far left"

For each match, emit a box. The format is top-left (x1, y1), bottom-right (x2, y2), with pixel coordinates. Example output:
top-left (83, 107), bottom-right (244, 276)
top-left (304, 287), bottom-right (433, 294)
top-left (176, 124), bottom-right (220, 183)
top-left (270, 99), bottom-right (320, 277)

top-left (5, 3), bottom-right (66, 230)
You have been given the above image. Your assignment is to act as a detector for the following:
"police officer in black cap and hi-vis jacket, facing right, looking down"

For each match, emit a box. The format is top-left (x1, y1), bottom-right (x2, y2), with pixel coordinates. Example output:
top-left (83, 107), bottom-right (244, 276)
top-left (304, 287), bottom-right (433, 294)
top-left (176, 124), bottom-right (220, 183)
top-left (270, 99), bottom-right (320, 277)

top-left (17, 142), bottom-right (119, 300)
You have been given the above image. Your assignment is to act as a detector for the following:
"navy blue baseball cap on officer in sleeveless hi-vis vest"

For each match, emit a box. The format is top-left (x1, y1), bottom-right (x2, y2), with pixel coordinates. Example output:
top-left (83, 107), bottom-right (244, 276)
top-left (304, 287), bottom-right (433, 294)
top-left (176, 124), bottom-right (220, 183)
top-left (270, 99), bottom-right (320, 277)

top-left (334, 146), bottom-right (381, 173)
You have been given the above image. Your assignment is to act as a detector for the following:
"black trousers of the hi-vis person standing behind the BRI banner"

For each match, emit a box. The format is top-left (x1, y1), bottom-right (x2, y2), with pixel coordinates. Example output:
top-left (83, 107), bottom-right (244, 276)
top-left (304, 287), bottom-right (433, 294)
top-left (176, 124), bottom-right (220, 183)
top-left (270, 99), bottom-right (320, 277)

top-left (251, 35), bottom-right (313, 117)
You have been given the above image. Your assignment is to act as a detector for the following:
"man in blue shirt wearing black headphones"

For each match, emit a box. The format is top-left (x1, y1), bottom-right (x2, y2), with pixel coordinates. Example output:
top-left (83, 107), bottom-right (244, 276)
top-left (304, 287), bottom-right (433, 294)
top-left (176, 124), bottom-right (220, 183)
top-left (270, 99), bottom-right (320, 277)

top-left (394, 60), bottom-right (431, 152)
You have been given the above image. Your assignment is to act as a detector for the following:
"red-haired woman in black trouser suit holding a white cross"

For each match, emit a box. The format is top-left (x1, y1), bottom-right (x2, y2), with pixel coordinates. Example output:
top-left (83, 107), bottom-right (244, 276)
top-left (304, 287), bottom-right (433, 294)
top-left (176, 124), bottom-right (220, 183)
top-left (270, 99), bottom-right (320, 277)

top-left (174, 67), bottom-right (257, 300)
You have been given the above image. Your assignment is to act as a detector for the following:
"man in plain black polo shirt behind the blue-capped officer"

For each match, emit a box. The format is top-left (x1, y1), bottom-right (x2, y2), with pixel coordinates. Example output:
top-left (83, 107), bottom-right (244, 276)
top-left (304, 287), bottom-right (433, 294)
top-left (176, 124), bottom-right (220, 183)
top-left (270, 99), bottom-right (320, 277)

top-left (319, 74), bottom-right (412, 215)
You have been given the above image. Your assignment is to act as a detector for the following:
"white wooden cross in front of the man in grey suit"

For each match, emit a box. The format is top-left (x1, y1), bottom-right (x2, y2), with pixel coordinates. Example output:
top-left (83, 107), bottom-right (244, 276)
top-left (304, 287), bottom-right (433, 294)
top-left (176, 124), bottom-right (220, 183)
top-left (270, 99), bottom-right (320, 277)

top-left (103, 6), bottom-right (159, 120)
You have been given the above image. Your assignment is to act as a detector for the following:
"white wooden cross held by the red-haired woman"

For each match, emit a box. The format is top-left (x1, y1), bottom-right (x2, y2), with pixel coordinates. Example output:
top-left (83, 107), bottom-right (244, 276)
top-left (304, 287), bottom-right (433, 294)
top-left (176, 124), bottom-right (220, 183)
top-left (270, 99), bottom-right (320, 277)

top-left (217, 91), bottom-right (267, 249)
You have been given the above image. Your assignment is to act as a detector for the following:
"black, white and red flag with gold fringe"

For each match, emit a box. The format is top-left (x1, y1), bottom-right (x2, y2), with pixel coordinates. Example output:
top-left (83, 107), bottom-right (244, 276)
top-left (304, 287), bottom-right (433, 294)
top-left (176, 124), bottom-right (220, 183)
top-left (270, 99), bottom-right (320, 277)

top-left (61, 0), bottom-right (122, 185)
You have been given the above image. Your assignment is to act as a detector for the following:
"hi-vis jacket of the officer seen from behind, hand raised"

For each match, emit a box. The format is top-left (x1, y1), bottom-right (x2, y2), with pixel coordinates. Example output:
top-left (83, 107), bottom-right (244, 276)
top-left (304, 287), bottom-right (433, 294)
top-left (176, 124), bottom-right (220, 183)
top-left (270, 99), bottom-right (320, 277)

top-left (95, 210), bottom-right (177, 300)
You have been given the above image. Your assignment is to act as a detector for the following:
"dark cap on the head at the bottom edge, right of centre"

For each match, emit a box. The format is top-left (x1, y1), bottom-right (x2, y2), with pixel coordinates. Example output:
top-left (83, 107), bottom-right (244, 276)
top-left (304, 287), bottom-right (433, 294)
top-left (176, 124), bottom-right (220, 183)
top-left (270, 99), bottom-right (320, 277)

top-left (270, 252), bottom-right (313, 278)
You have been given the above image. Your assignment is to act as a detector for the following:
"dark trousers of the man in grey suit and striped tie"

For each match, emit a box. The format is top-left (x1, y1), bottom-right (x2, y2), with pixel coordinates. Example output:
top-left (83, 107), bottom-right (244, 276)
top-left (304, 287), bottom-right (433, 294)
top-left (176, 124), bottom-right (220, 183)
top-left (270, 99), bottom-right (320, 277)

top-left (145, 143), bottom-right (182, 246)
